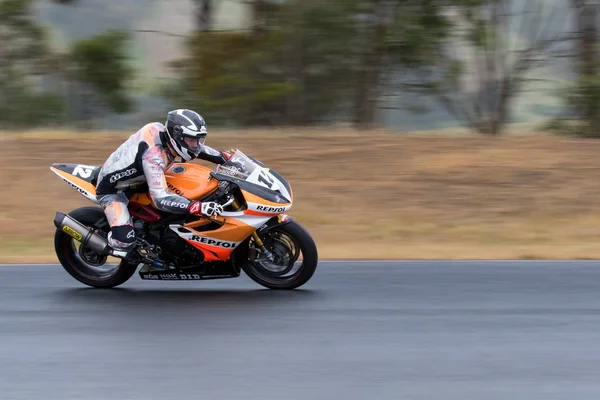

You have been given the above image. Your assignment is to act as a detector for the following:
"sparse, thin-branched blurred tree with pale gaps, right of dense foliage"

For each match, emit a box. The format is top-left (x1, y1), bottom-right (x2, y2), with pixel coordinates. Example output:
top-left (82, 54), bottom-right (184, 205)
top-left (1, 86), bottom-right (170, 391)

top-left (400, 0), bottom-right (568, 135)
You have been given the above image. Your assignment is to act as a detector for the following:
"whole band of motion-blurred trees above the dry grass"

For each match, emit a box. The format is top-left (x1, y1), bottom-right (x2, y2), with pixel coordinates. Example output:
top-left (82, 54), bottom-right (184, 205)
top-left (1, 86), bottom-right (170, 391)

top-left (0, 0), bottom-right (600, 137)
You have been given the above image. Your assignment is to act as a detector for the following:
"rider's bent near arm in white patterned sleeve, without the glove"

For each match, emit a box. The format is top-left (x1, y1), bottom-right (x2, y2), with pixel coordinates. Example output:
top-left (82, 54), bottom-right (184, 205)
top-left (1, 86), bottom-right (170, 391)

top-left (142, 146), bottom-right (192, 214)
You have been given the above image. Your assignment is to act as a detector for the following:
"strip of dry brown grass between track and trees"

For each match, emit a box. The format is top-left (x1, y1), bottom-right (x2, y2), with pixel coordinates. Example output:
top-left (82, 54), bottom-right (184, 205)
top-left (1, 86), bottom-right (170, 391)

top-left (0, 129), bottom-right (600, 262)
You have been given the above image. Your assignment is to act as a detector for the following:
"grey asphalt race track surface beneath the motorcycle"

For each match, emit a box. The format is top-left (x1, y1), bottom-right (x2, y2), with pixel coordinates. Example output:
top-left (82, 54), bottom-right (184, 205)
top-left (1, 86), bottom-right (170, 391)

top-left (0, 262), bottom-right (600, 400)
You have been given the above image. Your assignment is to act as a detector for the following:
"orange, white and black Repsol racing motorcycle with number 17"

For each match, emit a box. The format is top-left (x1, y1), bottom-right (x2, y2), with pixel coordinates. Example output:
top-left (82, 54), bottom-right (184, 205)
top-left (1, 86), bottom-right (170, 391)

top-left (50, 149), bottom-right (318, 289)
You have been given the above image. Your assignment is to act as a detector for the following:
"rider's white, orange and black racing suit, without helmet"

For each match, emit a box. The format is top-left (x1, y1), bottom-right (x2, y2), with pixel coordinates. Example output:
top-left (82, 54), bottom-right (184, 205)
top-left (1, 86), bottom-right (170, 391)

top-left (96, 122), bottom-right (227, 251)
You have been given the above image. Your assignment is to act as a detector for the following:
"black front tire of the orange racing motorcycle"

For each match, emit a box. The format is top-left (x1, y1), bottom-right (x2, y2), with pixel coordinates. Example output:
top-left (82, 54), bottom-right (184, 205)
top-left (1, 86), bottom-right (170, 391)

top-left (242, 221), bottom-right (319, 290)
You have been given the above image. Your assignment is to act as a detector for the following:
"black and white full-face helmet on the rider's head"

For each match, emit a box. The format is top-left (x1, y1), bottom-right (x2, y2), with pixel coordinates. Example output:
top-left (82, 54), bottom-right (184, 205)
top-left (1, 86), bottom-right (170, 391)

top-left (165, 109), bottom-right (208, 161)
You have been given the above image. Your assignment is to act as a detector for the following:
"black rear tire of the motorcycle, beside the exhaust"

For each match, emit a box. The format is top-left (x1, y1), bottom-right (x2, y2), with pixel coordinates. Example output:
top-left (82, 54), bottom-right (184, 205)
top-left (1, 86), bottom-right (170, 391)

top-left (54, 207), bottom-right (138, 288)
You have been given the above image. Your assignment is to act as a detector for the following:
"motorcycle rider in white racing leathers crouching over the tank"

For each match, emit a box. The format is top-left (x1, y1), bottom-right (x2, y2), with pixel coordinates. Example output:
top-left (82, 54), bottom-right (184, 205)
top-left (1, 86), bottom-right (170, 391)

top-left (96, 109), bottom-right (229, 259)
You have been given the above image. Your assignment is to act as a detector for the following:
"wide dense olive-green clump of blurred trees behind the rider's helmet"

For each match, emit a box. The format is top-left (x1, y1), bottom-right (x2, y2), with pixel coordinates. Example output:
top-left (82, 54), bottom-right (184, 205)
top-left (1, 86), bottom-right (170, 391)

top-left (167, 0), bottom-right (444, 127)
